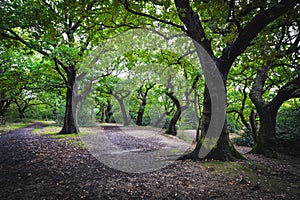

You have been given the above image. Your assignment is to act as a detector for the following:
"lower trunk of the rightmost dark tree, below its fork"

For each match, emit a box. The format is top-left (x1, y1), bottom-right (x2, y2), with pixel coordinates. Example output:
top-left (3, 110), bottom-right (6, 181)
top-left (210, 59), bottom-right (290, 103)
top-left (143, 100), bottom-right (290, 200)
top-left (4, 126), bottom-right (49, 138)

top-left (252, 106), bottom-right (278, 158)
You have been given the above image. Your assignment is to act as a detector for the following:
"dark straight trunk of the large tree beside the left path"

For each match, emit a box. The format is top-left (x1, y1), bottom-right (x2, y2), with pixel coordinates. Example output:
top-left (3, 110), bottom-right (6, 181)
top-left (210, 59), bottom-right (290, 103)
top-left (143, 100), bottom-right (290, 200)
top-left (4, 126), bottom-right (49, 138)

top-left (59, 66), bottom-right (79, 134)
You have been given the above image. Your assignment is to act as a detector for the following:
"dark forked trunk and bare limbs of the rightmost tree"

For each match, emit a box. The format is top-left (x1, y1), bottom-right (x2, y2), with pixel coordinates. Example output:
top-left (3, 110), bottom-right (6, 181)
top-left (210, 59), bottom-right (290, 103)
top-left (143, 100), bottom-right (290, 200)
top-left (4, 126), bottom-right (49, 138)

top-left (250, 62), bottom-right (300, 158)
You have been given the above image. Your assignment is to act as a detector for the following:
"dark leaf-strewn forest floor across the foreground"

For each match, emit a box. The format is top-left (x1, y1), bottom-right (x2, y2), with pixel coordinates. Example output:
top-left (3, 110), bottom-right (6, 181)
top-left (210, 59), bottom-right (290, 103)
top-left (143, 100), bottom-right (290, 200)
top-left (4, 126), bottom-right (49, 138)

top-left (0, 124), bottom-right (300, 199)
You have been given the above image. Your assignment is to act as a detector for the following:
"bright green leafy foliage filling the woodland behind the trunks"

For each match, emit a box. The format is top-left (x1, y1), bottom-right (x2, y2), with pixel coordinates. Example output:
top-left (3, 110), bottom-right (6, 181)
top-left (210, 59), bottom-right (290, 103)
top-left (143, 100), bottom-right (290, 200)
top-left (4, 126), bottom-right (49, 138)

top-left (0, 0), bottom-right (299, 158)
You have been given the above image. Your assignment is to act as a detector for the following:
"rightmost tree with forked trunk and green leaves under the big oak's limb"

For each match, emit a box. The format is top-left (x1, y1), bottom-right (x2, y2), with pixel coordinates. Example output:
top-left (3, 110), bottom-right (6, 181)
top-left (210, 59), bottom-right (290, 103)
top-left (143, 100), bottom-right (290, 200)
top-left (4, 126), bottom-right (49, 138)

top-left (226, 6), bottom-right (299, 157)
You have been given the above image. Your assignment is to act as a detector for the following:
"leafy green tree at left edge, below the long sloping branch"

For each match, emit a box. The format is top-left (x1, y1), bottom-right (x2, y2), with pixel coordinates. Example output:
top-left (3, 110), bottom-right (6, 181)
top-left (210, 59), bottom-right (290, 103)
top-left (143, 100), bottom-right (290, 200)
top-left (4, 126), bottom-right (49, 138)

top-left (0, 45), bottom-right (63, 118)
